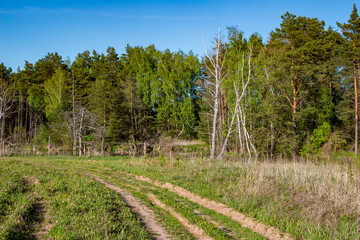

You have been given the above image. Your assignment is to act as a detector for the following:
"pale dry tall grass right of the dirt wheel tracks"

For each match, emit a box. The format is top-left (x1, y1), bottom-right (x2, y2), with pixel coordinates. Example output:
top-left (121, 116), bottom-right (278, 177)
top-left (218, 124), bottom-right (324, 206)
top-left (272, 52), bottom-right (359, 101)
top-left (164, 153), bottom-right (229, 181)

top-left (183, 161), bottom-right (360, 226)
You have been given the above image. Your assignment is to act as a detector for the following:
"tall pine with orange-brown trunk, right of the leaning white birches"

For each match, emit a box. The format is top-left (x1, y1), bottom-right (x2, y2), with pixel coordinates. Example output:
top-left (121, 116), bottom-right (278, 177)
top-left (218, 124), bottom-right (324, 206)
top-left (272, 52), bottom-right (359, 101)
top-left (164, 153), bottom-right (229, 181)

top-left (268, 12), bottom-right (325, 159)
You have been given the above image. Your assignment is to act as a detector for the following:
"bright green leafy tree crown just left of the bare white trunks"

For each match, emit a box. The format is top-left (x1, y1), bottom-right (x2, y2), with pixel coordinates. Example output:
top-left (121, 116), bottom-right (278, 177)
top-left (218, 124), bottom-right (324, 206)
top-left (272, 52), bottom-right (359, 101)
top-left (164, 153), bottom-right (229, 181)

top-left (155, 50), bottom-right (200, 135)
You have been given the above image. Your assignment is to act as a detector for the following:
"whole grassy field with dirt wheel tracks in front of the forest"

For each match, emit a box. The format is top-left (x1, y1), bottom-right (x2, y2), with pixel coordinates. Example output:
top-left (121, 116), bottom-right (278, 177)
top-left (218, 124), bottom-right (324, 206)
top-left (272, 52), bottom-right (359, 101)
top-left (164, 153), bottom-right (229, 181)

top-left (0, 157), bottom-right (360, 239)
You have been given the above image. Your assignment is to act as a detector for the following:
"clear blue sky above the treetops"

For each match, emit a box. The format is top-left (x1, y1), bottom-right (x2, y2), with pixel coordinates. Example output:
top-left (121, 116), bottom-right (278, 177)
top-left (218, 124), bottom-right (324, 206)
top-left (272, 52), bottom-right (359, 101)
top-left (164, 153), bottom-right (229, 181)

top-left (0, 0), bottom-right (360, 71)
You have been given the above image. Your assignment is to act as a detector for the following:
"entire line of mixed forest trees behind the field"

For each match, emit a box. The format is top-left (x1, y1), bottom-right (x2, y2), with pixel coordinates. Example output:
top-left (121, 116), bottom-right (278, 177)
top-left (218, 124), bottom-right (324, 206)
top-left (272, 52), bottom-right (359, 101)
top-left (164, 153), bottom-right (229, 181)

top-left (0, 5), bottom-right (360, 158)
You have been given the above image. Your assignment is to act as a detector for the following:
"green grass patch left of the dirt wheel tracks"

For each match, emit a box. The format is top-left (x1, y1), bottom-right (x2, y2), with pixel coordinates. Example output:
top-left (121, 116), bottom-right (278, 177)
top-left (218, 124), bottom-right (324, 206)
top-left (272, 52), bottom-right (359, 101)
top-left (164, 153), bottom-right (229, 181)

top-left (0, 160), bottom-right (152, 239)
